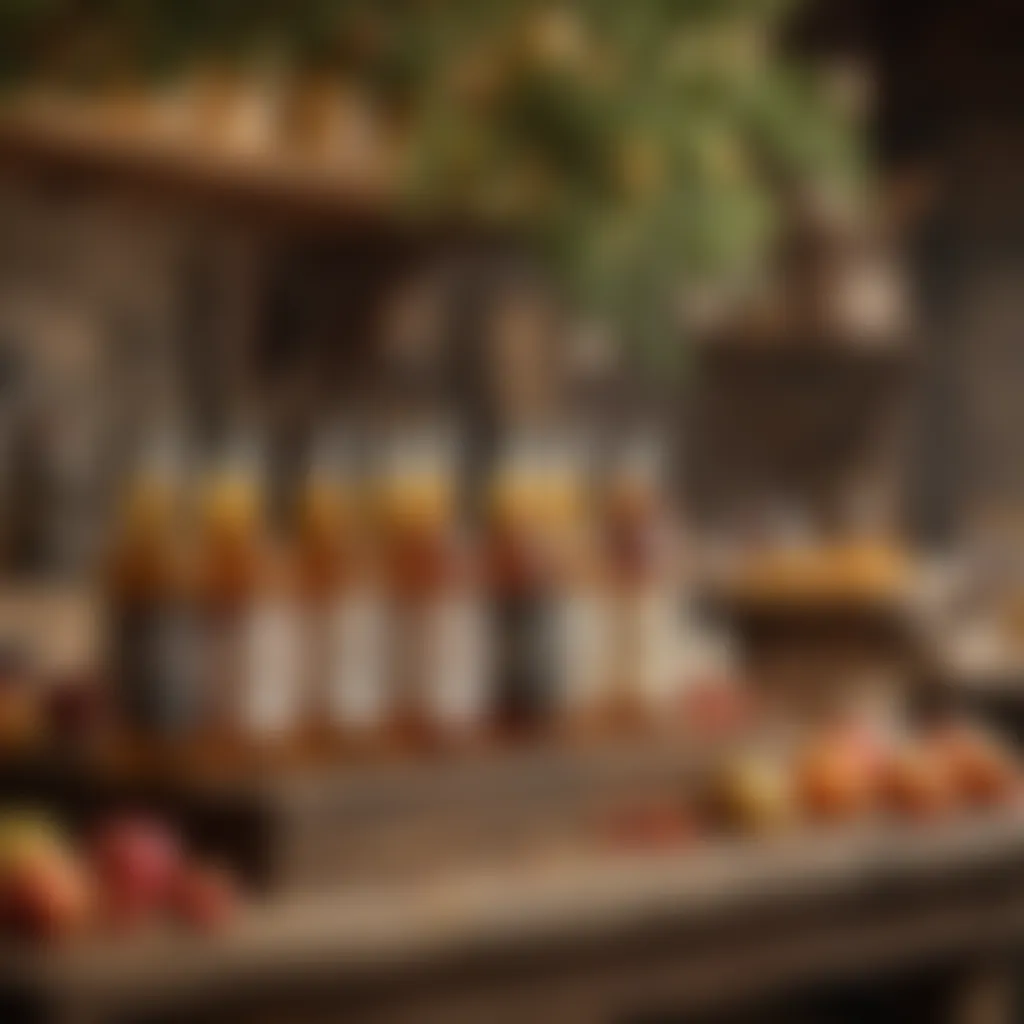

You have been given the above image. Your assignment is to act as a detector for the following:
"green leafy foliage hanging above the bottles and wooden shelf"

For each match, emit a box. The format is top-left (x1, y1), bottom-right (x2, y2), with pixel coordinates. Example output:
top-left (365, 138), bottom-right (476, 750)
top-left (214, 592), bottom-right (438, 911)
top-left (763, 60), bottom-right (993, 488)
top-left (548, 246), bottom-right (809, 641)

top-left (0, 0), bottom-right (862, 360)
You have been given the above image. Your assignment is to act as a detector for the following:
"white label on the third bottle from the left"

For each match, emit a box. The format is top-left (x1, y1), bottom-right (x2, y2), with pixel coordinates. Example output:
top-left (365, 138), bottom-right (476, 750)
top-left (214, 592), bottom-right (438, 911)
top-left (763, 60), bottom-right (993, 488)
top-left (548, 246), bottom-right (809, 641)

top-left (326, 594), bottom-right (390, 729)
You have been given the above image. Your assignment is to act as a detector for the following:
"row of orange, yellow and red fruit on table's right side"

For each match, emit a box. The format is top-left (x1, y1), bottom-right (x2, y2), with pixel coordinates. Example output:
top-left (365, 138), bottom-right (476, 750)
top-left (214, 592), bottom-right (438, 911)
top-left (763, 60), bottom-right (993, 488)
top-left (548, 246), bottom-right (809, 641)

top-left (602, 722), bottom-right (1024, 849)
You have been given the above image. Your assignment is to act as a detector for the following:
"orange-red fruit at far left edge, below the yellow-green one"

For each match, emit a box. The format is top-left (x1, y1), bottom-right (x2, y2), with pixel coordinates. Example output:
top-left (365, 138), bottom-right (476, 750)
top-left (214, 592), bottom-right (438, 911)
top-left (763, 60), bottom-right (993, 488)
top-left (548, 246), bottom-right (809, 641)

top-left (0, 853), bottom-right (93, 940)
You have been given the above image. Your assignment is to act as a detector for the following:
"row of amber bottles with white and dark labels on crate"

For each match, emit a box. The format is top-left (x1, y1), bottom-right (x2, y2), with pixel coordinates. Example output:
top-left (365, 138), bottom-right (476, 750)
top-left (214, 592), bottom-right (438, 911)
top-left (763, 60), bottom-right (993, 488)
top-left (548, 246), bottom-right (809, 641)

top-left (106, 432), bottom-right (679, 761)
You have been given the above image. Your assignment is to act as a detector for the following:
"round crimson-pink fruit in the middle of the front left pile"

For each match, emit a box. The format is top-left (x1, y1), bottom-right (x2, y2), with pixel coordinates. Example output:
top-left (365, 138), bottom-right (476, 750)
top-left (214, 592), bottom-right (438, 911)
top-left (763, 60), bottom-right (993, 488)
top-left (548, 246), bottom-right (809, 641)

top-left (92, 818), bottom-right (181, 924)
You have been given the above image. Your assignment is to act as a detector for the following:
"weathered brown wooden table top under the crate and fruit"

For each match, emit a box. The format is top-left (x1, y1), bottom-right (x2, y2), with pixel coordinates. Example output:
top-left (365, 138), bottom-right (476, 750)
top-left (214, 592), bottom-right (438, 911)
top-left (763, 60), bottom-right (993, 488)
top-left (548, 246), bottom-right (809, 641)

top-left (6, 810), bottom-right (1024, 1019)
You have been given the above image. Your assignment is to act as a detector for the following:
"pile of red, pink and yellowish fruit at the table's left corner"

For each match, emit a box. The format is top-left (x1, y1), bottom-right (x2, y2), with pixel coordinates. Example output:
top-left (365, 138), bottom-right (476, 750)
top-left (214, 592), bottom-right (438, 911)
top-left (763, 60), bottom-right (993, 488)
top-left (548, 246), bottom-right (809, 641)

top-left (0, 812), bottom-right (238, 941)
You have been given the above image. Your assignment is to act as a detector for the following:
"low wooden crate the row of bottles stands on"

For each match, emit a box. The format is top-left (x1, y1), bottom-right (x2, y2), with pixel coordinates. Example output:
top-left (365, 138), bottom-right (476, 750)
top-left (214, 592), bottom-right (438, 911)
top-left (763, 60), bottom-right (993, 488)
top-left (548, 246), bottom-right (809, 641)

top-left (0, 736), bottom-right (728, 892)
